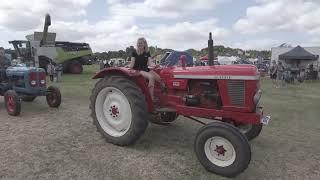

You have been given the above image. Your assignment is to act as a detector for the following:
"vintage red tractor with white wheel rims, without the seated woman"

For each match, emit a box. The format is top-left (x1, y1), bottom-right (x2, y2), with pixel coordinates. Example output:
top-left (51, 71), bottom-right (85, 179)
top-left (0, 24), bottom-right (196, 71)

top-left (90, 34), bottom-right (270, 177)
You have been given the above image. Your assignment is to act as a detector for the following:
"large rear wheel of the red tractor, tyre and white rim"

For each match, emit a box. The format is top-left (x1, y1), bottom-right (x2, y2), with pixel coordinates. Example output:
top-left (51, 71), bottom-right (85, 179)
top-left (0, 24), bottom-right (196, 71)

top-left (90, 76), bottom-right (148, 146)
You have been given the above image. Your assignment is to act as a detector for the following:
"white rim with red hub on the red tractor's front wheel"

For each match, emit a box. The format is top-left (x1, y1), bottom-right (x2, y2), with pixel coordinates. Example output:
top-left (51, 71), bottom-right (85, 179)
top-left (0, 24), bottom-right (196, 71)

top-left (204, 136), bottom-right (236, 167)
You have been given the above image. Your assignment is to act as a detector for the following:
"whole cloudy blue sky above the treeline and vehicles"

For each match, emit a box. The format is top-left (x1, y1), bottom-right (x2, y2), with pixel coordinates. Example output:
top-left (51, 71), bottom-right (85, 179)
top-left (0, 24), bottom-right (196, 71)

top-left (0, 0), bottom-right (320, 51)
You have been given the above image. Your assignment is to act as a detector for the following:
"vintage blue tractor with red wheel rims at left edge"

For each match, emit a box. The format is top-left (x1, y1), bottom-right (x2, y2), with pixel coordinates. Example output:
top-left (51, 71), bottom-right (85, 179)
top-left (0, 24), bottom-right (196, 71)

top-left (0, 65), bottom-right (61, 116)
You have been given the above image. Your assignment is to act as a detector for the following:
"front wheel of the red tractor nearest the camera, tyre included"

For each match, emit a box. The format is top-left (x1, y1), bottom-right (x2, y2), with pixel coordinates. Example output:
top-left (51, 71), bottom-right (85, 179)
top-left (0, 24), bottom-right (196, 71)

top-left (194, 122), bottom-right (251, 177)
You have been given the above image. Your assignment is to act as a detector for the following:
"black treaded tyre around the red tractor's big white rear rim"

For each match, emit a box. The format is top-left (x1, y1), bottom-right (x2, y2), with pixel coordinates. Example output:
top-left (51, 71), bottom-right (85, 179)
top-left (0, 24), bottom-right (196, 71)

top-left (90, 75), bottom-right (149, 146)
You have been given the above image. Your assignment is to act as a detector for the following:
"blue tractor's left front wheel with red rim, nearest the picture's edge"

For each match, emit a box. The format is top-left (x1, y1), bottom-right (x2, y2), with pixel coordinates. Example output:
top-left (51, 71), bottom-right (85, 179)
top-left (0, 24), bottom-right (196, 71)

top-left (4, 90), bottom-right (21, 116)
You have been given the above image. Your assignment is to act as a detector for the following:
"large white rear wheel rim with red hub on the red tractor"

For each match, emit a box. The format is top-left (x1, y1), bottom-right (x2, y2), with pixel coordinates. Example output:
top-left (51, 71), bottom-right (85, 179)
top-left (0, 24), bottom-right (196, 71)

top-left (95, 87), bottom-right (132, 137)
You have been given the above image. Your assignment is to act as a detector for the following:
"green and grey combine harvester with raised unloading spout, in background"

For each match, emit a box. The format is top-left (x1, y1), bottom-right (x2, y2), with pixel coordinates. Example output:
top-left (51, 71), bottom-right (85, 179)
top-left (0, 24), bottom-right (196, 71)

top-left (9, 14), bottom-right (93, 74)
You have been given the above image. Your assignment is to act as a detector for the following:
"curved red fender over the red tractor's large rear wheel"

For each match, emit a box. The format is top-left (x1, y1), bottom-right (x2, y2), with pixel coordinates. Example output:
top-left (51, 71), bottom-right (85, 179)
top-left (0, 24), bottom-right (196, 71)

top-left (92, 67), bottom-right (154, 113)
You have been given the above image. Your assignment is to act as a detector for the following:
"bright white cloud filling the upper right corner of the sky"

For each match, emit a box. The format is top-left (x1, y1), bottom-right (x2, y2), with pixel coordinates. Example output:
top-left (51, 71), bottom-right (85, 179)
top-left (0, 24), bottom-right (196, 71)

top-left (233, 0), bottom-right (320, 34)
